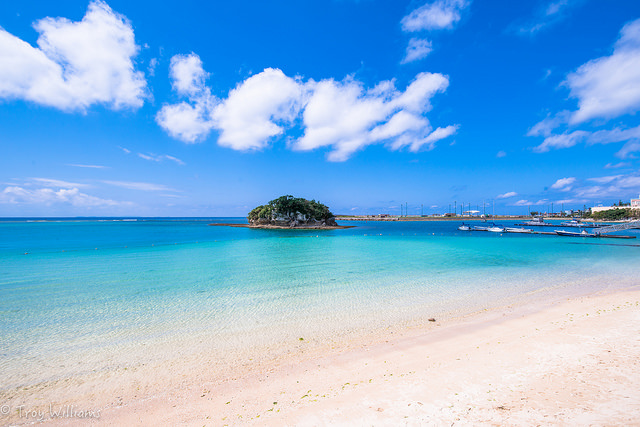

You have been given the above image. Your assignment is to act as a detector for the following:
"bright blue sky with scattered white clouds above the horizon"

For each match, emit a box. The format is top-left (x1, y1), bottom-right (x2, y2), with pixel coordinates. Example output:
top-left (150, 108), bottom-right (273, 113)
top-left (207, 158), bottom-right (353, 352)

top-left (0, 0), bottom-right (640, 217)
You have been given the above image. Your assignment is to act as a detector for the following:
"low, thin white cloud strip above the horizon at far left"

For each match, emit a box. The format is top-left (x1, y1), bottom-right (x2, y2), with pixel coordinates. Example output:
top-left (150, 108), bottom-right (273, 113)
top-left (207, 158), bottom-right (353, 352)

top-left (0, 186), bottom-right (126, 208)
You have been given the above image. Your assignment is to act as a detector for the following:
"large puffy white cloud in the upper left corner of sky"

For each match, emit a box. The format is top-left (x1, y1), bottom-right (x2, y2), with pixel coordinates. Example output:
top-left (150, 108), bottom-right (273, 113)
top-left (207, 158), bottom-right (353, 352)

top-left (0, 0), bottom-right (148, 111)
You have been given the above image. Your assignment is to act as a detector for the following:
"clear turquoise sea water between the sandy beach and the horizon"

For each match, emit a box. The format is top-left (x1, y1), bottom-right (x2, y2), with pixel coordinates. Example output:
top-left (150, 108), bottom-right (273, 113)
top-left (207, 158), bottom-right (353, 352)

top-left (0, 218), bottom-right (640, 390)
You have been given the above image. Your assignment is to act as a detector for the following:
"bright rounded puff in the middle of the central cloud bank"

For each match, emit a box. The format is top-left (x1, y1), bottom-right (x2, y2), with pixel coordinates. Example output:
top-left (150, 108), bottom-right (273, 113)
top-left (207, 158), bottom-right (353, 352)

top-left (213, 68), bottom-right (305, 150)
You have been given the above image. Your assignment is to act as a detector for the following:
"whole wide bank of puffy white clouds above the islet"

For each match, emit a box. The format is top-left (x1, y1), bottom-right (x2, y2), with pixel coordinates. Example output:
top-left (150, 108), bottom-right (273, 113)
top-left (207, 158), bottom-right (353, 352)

top-left (156, 54), bottom-right (458, 161)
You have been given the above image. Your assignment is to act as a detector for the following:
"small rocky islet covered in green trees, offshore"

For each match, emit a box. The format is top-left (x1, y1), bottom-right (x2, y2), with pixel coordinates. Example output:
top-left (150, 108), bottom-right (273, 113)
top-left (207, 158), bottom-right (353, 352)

top-left (247, 195), bottom-right (337, 227)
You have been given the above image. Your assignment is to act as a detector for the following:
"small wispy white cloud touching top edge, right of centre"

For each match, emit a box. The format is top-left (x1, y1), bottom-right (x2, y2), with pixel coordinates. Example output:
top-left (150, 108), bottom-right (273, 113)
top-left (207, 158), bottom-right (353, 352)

top-left (401, 0), bottom-right (471, 32)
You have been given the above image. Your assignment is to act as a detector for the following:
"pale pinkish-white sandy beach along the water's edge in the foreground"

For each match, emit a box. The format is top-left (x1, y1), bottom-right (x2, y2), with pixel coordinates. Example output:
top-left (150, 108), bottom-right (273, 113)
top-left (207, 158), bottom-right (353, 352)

top-left (7, 287), bottom-right (640, 426)
